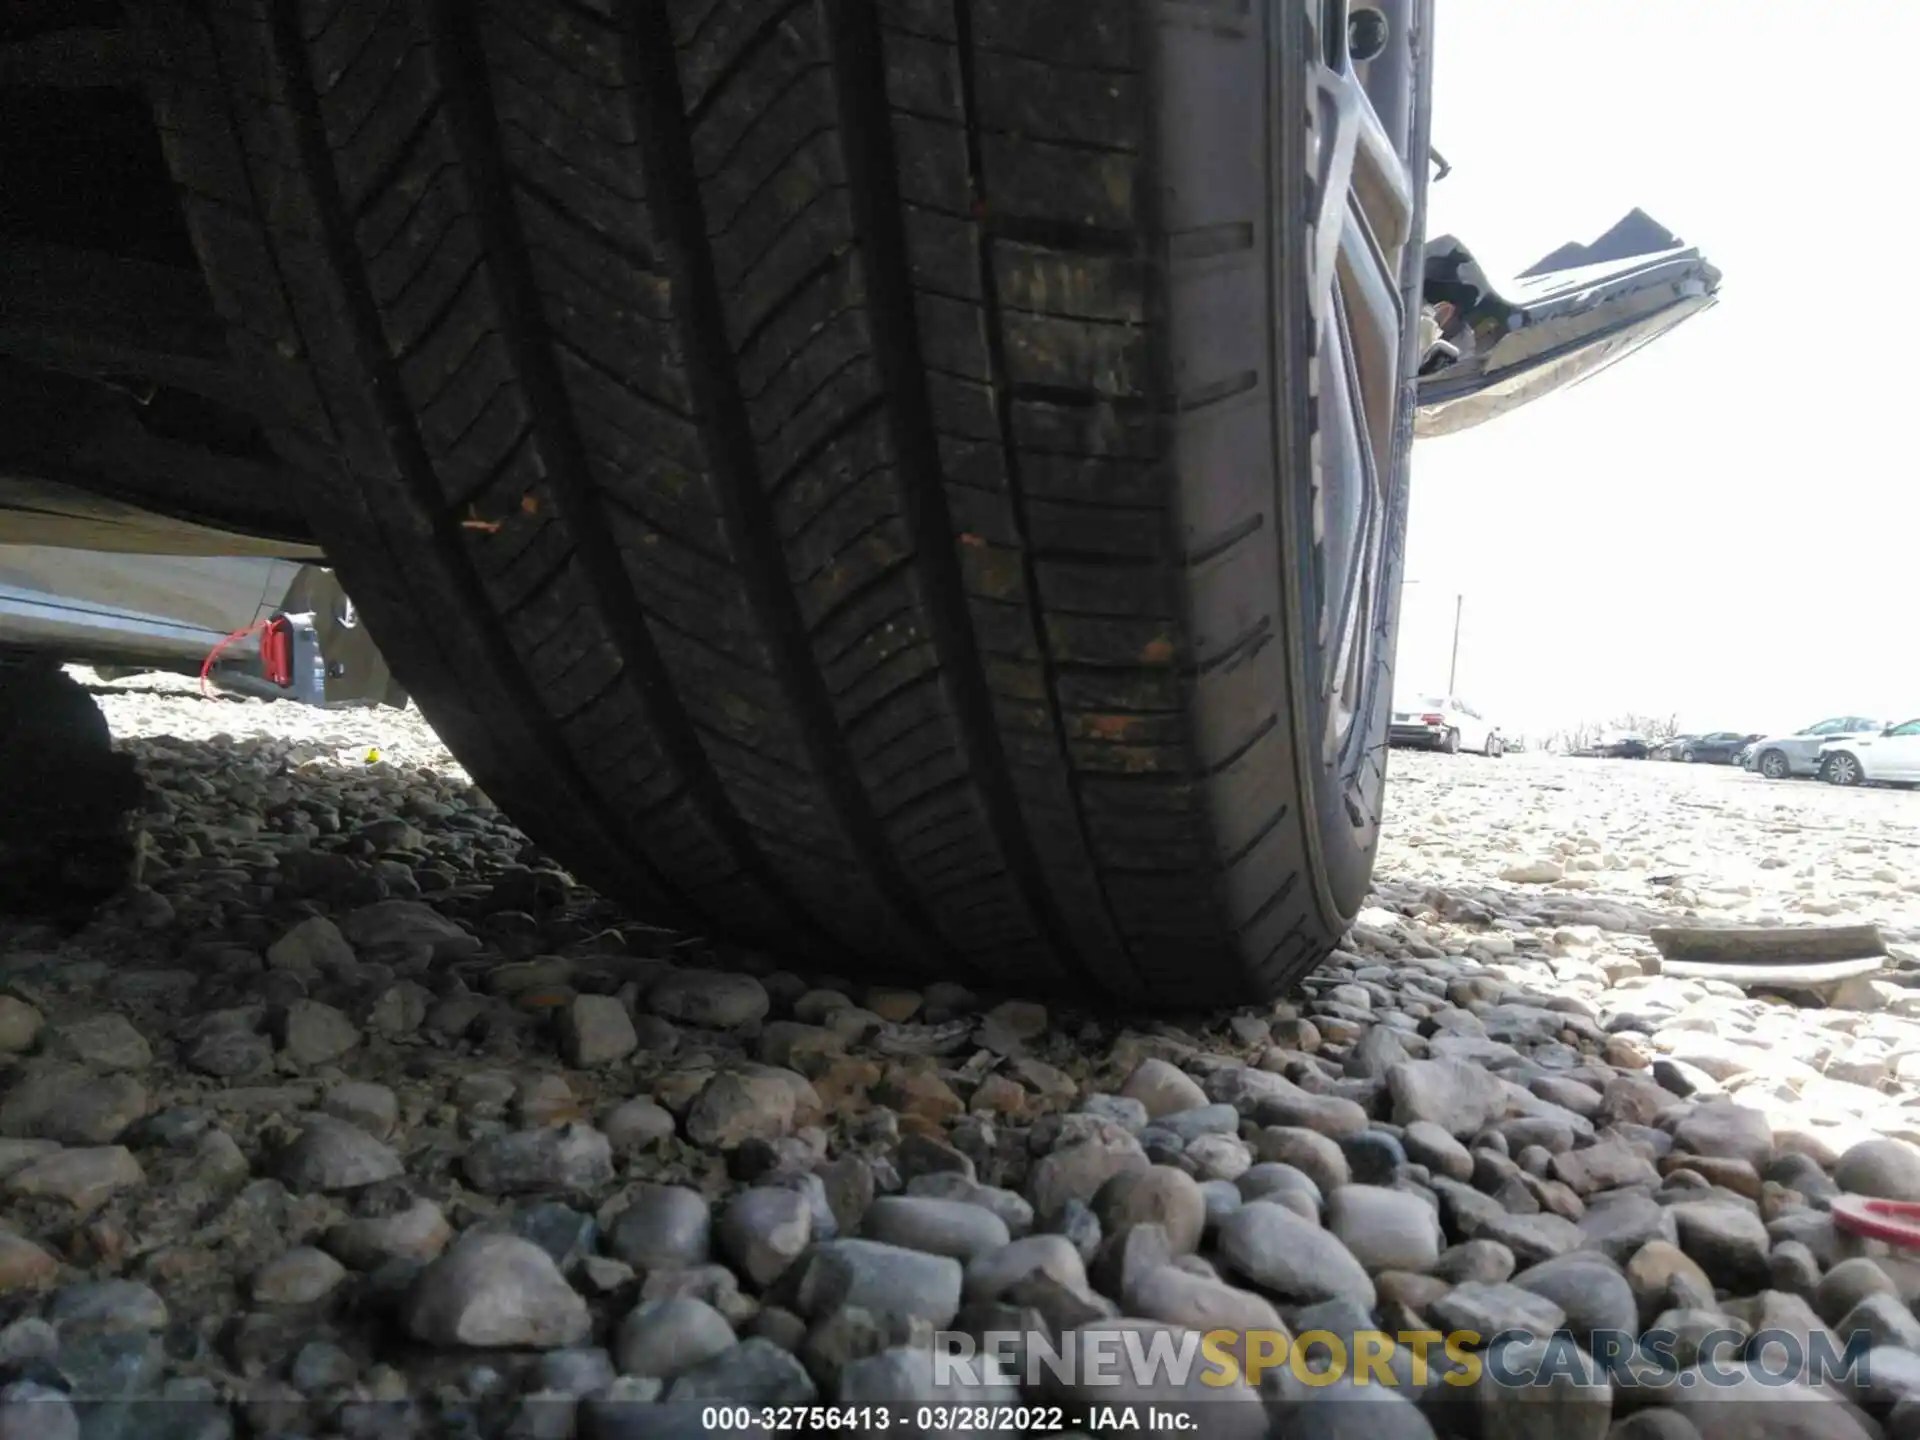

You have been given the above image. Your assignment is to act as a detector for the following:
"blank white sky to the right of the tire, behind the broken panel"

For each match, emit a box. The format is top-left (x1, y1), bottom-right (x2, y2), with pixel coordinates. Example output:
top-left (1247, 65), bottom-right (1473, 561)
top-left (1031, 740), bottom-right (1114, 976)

top-left (1398, 0), bottom-right (1920, 735)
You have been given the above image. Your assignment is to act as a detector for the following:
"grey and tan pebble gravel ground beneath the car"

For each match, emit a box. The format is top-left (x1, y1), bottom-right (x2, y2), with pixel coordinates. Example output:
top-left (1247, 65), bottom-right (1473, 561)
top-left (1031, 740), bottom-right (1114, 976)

top-left (0, 680), bottom-right (1920, 1440)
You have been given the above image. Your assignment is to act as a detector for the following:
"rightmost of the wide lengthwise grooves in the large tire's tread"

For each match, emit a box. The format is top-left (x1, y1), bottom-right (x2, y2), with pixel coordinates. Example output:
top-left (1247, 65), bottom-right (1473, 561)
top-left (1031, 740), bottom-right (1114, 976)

top-left (828, 0), bottom-right (1102, 993)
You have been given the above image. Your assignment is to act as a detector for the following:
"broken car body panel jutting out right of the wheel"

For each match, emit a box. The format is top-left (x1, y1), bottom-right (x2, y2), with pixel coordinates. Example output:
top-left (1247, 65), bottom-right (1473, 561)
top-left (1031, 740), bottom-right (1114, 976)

top-left (1415, 209), bottom-right (1720, 438)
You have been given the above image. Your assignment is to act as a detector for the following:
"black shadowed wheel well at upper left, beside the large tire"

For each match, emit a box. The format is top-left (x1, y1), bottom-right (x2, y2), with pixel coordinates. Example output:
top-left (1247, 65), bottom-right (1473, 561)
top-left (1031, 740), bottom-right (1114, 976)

top-left (0, 9), bottom-right (311, 543)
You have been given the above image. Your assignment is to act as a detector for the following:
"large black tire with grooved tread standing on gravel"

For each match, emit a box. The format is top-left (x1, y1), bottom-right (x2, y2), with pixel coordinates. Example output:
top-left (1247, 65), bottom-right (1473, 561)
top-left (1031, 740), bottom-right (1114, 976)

top-left (145, 0), bottom-right (1428, 1004)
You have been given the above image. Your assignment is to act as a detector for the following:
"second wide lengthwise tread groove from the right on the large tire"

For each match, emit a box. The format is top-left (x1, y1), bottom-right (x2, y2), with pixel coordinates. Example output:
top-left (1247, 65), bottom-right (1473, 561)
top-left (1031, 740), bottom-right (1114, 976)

top-left (620, 0), bottom-right (962, 966)
